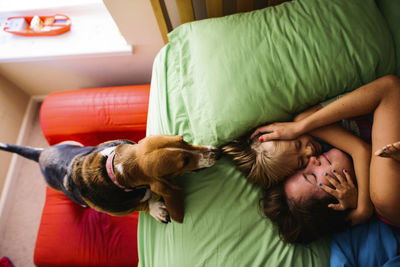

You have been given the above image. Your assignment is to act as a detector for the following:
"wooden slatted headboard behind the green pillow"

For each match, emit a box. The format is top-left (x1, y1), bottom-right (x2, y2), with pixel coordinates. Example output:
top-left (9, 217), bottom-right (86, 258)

top-left (150, 0), bottom-right (290, 43)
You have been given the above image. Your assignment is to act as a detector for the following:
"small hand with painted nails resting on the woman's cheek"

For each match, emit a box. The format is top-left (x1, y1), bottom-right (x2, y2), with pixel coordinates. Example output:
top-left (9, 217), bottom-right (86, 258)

top-left (320, 170), bottom-right (358, 210)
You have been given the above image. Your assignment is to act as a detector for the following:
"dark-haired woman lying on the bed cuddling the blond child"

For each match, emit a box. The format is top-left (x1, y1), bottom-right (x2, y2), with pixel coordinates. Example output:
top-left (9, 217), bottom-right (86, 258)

top-left (256, 76), bottom-right (400, 243)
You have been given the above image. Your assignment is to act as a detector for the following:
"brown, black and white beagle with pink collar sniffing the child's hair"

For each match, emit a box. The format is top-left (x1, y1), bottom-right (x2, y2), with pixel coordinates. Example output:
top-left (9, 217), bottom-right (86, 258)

top-left (0, 135), bottom-right (219, 223)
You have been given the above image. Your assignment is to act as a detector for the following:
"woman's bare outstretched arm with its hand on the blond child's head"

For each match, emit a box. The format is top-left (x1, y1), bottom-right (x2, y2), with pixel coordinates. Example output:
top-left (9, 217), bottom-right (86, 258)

top-left (251, 75), bottom-right (398, 141)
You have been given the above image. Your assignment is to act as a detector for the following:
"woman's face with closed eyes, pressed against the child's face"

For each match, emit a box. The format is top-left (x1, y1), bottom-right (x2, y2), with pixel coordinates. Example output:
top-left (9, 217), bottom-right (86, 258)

top-left (284, 148), bottom-right (353, 199)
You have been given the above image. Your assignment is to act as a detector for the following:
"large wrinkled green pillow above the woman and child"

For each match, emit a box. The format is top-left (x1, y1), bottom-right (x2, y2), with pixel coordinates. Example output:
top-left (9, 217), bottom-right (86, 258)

top-left (150, 0), bottom-right (395, 145)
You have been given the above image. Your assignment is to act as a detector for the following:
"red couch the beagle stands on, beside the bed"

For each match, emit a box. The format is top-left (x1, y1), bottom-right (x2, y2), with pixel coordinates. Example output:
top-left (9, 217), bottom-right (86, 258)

top-left (34, 85), bottom-right (150, 267)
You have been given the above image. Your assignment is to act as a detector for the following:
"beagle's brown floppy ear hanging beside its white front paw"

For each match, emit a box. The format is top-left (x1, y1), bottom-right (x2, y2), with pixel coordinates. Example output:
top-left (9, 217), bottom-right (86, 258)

top-left (150, 181), bottom-right (184, 223)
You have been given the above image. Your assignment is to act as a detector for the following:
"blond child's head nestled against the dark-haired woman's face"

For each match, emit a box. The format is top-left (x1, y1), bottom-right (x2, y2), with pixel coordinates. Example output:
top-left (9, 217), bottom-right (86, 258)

top-left (222, 131), bottom-right (322, 189)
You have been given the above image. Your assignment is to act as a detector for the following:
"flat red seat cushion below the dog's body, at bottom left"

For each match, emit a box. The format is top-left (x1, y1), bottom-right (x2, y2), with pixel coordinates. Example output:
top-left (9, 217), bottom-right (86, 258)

top-left (34, 188), bottom-right (138, 267)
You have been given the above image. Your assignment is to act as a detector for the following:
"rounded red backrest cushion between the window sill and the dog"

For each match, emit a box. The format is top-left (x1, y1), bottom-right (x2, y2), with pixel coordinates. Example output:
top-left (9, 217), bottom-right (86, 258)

top-left (40, 85), bottom-right (150, 145)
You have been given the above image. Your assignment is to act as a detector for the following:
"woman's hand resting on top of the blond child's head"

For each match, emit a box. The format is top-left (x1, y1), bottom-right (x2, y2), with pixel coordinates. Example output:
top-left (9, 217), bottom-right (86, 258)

top-left (250, 122), bottom-right (302, 142)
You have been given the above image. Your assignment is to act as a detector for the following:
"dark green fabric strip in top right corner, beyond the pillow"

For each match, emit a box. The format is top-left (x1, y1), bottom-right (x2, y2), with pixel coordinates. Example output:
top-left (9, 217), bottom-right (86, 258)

top-left (376, 0), bottom-right (400, 77)
